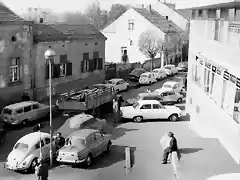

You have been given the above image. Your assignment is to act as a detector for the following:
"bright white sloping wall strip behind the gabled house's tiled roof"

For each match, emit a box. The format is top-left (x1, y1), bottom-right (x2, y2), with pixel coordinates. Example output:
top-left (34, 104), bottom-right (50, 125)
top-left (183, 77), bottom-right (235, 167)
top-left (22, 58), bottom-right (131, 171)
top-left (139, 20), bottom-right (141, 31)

top-left (152, 2), bottom-right (188, 30)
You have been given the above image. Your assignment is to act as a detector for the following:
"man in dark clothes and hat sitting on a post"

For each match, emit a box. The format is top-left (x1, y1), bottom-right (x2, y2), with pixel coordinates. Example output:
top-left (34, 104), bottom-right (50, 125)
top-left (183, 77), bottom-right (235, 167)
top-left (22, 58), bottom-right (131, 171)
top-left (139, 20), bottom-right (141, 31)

top-left (162, 132), bottom-right (178, 164)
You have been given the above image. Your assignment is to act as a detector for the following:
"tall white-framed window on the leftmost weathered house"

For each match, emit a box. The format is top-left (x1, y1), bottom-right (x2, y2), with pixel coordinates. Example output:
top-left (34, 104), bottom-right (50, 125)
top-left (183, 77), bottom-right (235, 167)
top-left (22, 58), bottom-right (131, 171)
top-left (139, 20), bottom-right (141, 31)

top-left (9, 58), bottom-right (20, 82)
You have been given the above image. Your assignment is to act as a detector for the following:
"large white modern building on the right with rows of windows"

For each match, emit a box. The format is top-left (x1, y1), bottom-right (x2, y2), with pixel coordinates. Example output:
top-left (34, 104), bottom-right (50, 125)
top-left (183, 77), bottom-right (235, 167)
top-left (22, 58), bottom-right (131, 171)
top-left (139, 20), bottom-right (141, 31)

top-left (177, 0), bottom-right (240, 163)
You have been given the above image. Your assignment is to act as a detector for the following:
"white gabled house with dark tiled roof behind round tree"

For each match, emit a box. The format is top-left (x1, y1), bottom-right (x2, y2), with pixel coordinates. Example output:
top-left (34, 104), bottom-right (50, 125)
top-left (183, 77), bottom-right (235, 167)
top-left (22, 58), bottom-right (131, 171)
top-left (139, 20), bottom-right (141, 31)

top-left (102, 6), bottom-right (183, 63)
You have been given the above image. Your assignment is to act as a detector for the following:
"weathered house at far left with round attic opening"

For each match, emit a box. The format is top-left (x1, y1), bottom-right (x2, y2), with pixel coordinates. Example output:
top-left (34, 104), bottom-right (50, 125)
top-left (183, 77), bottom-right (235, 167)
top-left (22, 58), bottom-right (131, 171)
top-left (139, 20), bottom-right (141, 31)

top-left (0, 3), bottom-right (34, 109)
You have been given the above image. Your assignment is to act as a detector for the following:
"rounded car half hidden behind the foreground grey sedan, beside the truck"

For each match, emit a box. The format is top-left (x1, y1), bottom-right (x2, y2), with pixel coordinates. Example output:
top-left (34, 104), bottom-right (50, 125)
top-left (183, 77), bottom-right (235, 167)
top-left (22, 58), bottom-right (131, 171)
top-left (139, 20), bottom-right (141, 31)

top-left (56, 113), bottom-right (107, 138)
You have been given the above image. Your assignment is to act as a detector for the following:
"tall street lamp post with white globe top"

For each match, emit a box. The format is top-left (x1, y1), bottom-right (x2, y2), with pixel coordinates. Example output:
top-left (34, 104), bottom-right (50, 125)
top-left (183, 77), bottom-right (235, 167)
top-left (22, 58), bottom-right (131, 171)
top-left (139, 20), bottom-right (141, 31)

top-left (44, 47), bottom-right (56, 167)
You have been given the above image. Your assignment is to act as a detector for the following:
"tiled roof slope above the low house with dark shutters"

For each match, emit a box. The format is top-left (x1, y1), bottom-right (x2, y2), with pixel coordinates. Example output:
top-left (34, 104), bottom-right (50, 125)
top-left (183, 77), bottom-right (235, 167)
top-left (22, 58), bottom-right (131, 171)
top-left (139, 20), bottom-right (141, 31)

top-left (53, 24), bottom-right (103, 36)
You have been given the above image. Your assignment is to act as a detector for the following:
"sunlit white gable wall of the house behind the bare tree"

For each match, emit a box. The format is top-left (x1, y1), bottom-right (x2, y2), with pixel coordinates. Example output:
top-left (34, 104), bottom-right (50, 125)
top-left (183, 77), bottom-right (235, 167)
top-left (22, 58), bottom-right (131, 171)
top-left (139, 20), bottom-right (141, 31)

top-left (102, 9), bottom-right (165, 63)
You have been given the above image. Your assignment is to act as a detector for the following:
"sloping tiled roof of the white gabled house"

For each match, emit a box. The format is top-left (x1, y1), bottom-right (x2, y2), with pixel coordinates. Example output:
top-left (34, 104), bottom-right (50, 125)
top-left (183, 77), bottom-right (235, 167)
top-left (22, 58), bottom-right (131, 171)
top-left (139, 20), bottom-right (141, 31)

top-left (133, 8), bottom-right (183, 33)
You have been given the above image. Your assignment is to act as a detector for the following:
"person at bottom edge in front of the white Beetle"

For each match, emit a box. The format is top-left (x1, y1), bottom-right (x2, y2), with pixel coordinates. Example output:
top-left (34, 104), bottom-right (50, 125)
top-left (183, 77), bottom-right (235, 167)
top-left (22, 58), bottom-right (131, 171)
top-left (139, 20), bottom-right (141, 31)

top-left (35, 157), bottom-right (48, 180)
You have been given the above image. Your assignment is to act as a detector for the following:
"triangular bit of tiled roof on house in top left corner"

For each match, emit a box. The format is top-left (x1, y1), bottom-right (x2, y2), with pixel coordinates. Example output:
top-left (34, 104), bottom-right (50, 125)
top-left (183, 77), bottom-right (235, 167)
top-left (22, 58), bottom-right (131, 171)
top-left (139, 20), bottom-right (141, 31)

top-left (0, 2), bottom-right (24, 21)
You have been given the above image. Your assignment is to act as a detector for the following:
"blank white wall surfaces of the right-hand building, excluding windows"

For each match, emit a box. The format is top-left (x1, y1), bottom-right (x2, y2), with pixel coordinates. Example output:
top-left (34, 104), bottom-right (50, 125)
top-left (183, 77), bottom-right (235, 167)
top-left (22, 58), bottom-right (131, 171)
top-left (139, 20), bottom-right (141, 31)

top-left (186, 20), bottom-right (240, 163)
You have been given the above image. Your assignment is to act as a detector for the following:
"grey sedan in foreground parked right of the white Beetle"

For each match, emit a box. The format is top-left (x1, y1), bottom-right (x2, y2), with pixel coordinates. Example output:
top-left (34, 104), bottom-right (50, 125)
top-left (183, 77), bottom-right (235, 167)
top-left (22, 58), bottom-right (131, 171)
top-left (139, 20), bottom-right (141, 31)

top-left (57, 129), bottom-right (112, 166)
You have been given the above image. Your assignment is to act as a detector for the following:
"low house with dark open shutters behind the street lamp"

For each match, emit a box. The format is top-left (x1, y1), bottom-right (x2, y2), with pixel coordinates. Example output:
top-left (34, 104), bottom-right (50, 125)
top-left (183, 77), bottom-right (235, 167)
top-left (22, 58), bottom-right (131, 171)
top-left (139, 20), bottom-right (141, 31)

top-left (34, 24), bottom-right (106, 99)
